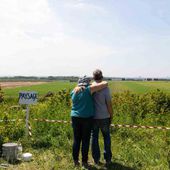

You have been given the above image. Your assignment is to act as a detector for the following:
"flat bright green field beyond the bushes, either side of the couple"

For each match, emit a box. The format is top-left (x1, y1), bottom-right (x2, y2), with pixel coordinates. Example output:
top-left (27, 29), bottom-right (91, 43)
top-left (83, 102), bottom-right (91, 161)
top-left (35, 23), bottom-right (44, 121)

top-left (3, 81), bottom-right (170, 97)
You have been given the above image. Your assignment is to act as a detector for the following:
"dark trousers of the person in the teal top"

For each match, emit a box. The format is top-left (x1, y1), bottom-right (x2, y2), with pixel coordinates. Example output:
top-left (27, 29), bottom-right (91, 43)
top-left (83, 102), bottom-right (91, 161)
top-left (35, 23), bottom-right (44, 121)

top-left (72, 117), bottom-right (93, 163)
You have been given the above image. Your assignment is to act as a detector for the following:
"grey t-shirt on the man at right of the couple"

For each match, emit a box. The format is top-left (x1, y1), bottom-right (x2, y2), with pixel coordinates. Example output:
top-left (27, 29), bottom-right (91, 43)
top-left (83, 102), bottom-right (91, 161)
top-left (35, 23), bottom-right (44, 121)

top-left (93, 87), bottom-right (111, 119)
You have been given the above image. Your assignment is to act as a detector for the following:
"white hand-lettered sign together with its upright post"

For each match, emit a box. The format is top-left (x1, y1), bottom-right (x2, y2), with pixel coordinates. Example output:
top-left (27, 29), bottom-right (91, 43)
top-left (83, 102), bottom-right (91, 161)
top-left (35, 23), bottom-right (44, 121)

top-left (19, 91), bottom-right (37, 137)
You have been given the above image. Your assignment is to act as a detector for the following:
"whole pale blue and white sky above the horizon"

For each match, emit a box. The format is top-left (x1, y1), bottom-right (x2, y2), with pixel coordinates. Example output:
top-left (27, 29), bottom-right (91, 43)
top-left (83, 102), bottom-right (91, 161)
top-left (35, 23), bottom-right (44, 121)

top-left (0, 0), bottom-right (170, 77)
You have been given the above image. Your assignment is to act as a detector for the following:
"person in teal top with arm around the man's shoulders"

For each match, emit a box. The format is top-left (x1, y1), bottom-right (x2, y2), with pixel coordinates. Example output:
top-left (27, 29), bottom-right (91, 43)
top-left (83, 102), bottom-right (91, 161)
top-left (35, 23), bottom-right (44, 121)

top-left (71, 76), bottom-right (108, 166)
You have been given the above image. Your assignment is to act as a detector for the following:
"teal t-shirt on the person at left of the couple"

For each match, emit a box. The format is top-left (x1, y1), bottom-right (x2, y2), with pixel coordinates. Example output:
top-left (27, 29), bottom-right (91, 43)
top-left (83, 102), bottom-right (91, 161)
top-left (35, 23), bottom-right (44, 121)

top-left (71, 86), bottom-right (94, 118)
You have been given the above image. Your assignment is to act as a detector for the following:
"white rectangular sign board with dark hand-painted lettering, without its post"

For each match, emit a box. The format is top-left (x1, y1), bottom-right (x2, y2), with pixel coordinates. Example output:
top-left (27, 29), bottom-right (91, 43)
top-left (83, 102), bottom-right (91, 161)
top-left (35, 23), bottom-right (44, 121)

top-left (19, 91), bottom-right (37, 104)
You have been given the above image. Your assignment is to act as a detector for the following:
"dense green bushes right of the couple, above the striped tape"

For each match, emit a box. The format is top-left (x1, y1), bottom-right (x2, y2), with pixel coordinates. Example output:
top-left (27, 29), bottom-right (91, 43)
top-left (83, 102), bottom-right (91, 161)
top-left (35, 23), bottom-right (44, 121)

top-left (112, 90), bottom-right (170, 126)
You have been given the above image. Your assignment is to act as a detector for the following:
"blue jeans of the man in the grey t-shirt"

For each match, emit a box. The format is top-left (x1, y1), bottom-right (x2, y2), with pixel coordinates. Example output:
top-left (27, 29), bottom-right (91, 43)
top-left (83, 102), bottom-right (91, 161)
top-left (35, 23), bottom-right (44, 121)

top-left (92, 118), bottom-right (112, 163)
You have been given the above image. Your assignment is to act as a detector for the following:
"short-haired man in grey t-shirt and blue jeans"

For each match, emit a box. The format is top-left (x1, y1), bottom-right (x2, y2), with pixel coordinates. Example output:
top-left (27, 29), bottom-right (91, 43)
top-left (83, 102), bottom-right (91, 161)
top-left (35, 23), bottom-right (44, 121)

top-left (92, 69), bottom-right (113, 165)
